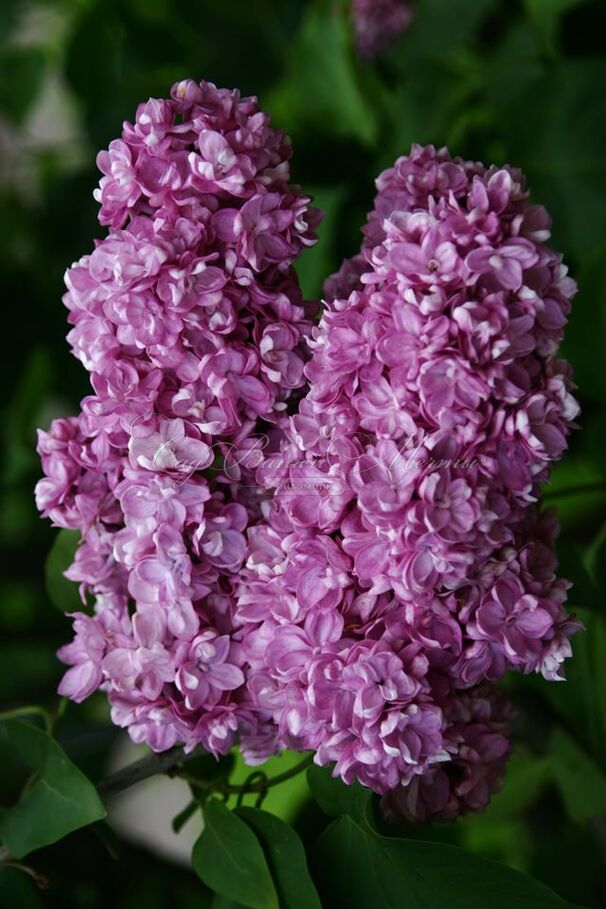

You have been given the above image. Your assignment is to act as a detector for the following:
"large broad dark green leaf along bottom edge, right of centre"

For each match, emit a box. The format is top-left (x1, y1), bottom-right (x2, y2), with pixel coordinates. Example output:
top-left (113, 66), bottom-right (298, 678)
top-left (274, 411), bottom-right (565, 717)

top-left (313, 817), bottom-right (566, 909)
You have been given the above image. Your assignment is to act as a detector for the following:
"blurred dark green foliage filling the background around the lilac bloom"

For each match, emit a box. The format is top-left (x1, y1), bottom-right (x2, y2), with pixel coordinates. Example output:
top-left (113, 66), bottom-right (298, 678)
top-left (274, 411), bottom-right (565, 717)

top-left (0, 0), bottom-right (606, 909)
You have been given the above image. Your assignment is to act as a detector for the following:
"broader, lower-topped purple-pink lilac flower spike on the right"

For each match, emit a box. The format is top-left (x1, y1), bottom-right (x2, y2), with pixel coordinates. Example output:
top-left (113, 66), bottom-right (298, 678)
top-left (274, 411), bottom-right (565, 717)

top-left (238, 146), bottom-right (579, 819)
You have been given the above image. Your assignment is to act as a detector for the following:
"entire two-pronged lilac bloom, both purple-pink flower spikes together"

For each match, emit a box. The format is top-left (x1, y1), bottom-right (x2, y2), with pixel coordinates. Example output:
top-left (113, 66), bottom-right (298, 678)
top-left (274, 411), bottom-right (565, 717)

top-left (36, 92), bottom-right (579, 819)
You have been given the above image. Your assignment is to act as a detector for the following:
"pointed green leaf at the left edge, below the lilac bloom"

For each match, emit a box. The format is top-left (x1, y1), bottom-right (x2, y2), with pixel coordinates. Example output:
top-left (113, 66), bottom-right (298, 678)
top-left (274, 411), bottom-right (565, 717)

top-left (0, 720), bottom-right (106, 858)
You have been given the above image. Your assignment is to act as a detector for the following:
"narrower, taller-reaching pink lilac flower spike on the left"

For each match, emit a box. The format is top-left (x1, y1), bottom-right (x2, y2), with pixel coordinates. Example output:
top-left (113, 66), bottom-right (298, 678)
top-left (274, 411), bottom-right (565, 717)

top-left (36, 81), bottom-right (319, 754)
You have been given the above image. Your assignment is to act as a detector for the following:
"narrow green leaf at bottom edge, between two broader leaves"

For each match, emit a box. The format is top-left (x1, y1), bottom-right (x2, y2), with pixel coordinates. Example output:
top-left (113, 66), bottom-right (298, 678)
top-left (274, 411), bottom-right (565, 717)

top-left (236, 808), bottom-right (322, 909)
